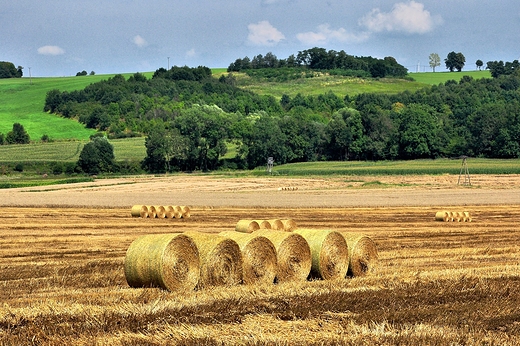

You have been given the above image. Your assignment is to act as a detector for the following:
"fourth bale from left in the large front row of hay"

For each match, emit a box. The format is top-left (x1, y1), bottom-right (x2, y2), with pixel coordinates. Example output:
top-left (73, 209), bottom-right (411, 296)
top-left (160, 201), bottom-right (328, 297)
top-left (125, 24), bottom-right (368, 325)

top-left (253, 229), bottom-right (312, 283)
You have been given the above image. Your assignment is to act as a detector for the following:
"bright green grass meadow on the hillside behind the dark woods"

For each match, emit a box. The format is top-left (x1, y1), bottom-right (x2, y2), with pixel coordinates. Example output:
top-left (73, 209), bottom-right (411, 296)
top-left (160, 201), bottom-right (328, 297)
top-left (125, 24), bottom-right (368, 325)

top-left (0, 68), bottom-right (489, 142)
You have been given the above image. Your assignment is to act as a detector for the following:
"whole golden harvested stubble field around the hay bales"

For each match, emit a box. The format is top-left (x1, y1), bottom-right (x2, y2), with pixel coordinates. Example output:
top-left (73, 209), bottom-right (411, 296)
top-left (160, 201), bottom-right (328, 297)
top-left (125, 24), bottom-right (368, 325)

top-left (0, 177), bottom-right (520, 346)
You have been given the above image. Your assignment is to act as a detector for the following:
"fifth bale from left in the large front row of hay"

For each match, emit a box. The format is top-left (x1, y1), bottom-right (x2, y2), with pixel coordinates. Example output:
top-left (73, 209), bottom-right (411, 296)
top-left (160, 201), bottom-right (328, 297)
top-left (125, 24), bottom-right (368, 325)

top-left (294, 229), bottom-right (349, 280)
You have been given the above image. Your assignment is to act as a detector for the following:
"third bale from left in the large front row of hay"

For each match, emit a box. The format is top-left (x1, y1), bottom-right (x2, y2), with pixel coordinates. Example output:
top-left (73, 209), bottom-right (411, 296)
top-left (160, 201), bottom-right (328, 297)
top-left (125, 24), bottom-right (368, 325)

top-left (220, 231), bottom-right (277, 285)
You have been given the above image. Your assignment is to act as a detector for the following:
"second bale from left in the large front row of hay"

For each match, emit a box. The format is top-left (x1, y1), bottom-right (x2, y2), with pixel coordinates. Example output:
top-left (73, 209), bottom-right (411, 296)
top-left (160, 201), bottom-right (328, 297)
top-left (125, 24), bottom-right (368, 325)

top-left (184, 231), bottom-right (242, 288)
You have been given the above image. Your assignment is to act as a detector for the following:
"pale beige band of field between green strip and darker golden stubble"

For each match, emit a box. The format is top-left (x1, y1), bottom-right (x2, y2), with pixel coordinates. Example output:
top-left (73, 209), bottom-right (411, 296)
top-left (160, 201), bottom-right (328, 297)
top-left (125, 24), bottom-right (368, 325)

top-left (0, 175), bottom-right (520, 208)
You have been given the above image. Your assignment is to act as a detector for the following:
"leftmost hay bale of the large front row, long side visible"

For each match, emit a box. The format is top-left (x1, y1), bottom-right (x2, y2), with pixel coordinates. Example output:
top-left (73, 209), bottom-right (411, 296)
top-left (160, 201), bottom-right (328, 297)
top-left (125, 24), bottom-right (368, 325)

top-left (125, 234), bottom-right (200, 291)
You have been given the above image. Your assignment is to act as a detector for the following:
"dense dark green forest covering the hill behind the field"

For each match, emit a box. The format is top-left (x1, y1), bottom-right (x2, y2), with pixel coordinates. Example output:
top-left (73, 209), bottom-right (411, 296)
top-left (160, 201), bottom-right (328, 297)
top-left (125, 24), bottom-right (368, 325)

top-left (45, 66), bottom-right (520, 172)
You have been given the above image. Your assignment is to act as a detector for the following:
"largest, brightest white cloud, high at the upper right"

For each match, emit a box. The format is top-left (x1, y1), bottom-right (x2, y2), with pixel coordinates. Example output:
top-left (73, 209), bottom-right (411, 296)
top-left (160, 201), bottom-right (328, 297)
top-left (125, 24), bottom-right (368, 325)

top-left (359, 1), bottom-right (442, 34)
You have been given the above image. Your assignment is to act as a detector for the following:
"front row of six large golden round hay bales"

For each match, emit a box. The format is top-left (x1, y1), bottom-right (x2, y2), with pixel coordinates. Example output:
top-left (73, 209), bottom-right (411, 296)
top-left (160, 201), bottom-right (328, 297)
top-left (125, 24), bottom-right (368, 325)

top-left (125, 229), bottom-right (378, 291)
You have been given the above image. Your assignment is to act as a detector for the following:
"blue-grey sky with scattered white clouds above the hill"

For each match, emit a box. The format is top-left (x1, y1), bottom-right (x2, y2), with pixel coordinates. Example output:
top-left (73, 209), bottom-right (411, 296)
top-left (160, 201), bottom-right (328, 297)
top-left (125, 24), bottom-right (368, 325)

top-left (0, 0), bottom-right (520, 76)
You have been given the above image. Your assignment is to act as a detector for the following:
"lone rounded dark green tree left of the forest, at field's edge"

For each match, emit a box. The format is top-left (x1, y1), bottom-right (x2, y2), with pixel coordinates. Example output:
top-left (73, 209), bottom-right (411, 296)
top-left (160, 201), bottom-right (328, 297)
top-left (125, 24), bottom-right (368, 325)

top-left (78, 137), bottom-right (116, 174)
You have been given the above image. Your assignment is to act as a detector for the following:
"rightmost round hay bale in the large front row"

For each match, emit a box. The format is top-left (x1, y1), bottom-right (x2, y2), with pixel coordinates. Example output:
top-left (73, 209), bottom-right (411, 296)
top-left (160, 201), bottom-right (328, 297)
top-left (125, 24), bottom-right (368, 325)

top-left (343, 233), bottom-right (379, 276)
